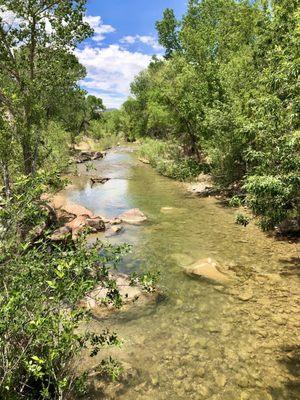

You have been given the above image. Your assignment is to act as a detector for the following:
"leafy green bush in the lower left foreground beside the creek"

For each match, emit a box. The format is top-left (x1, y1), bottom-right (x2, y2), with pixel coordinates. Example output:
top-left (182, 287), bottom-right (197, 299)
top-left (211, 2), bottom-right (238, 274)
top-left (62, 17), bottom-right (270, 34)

top-left (0, 238), bottom-right (127, 399)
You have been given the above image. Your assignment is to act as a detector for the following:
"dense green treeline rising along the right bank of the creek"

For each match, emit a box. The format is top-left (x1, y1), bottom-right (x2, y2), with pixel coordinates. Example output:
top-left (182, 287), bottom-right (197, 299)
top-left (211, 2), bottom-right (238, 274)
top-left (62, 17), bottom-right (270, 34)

top-left (121, 0), bottom-right (300, 229)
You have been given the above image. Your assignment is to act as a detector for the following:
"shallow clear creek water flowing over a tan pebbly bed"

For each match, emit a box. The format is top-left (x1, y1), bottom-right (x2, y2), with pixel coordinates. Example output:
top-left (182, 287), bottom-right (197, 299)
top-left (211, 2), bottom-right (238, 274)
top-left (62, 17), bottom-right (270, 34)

top-left (65, 148), bottom-right (300, 400)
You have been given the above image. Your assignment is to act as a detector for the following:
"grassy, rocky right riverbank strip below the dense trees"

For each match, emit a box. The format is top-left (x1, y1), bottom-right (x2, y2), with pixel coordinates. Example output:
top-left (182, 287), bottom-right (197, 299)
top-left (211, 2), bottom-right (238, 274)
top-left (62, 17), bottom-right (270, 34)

top-left (138, 138), bottom-right (300, 239)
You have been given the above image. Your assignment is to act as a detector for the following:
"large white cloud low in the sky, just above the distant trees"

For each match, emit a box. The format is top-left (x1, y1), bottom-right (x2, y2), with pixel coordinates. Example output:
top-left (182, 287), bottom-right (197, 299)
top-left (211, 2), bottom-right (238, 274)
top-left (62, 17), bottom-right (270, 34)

top-left (75, 45), bottom-right (151, 107)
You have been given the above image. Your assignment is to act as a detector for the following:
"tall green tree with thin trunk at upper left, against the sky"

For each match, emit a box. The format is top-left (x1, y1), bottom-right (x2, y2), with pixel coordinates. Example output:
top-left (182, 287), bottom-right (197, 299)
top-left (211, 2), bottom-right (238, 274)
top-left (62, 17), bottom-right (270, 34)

top-left (0, 0), bottom-right (92, 175)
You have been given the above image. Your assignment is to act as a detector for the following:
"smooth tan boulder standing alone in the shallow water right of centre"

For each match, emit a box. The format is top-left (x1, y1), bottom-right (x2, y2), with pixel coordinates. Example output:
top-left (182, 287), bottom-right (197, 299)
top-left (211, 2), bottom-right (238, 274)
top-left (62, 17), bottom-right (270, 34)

top-left (184, 258), bottom-right (230, 284)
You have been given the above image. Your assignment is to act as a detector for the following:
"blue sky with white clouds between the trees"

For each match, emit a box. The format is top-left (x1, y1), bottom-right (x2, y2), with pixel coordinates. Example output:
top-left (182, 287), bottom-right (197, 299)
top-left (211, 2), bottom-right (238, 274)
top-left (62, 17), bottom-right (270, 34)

top-left (76, 0), bottom-right (187, 108)
